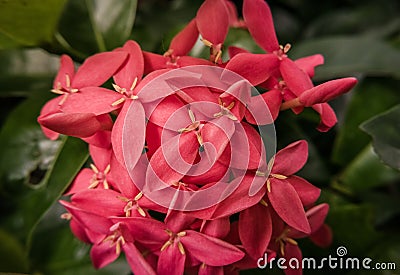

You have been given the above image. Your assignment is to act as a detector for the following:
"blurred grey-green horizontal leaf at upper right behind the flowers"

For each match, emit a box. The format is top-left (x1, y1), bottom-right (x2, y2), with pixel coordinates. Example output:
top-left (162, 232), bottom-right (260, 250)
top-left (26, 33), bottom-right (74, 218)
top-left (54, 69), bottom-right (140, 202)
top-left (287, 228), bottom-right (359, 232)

top-left (290, 36), bottom-right (400, 80)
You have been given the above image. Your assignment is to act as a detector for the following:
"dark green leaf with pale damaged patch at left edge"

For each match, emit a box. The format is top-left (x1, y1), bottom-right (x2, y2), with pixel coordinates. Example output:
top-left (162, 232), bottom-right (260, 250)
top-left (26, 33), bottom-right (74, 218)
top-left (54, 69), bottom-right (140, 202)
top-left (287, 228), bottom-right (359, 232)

top-left (0, 93), bottom-right (59, 189)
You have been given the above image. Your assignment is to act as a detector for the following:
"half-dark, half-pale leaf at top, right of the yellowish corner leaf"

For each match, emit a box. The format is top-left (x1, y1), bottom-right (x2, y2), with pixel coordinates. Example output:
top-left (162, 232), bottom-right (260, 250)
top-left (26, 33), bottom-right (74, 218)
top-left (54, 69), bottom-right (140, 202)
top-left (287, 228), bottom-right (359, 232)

top-left (56, 0), bottom-right (137, 56)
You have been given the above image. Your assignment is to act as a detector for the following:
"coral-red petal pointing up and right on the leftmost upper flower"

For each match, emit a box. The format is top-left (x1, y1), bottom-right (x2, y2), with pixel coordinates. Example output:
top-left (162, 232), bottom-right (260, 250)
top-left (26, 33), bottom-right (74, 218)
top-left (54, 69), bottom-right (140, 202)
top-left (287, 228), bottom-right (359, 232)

top-left (71, 52), bottom-right (127, 89)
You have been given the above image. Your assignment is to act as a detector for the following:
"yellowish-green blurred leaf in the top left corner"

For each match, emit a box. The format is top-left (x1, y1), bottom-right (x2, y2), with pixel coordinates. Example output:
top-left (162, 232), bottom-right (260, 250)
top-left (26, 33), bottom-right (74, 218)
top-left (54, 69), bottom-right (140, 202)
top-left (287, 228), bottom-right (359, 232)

top-left (0, 0), bottom-right (66, 49)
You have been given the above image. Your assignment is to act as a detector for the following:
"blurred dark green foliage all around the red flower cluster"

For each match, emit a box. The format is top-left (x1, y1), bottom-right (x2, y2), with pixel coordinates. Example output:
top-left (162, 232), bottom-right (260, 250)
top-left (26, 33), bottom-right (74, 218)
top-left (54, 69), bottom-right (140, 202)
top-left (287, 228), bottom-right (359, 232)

top-left (0, 0), bottom-right (400, 275)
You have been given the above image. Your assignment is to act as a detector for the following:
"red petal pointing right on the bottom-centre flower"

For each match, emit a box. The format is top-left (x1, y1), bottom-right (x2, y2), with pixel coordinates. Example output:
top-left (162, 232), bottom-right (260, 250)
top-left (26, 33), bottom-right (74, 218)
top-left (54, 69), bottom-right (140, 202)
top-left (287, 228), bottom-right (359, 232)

top-left (181, 230), bottom-right (244, 266)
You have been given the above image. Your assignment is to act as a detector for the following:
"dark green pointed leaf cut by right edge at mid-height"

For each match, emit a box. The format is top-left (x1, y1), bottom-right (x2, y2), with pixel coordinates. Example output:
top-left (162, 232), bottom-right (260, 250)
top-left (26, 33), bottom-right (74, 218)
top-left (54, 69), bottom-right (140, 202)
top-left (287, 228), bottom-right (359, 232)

top-left (360, 104), bottom-right (400, 170)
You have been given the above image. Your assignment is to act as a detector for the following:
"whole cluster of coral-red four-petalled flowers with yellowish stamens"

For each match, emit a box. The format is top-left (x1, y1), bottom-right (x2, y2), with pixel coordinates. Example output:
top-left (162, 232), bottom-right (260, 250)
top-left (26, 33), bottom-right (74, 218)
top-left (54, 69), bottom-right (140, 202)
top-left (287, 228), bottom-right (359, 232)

top-left (38, 0), bottom-right (357, 274)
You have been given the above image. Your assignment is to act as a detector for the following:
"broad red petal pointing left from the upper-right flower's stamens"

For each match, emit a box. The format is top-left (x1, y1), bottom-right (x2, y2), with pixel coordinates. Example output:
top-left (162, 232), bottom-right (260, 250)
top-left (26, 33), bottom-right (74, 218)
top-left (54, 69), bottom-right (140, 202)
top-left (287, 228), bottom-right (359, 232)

top-left (225, 53), bottom-right (279, 86)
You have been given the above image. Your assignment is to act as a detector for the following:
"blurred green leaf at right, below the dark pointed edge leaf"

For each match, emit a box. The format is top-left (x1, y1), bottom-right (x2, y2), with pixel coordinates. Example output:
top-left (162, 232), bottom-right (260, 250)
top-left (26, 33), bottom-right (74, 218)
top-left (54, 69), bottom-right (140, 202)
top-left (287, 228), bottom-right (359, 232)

top-left (338, 146), bottom-right (400, 194)
